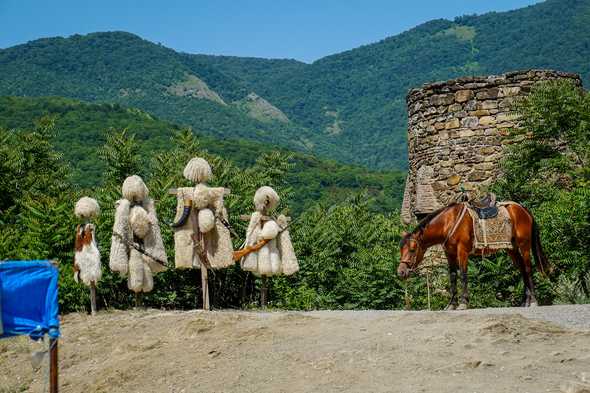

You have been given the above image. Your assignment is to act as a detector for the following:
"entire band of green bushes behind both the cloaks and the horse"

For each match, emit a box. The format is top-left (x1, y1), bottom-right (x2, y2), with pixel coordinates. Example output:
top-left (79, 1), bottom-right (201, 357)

top-left (0, 82), bottom-right (590, 312)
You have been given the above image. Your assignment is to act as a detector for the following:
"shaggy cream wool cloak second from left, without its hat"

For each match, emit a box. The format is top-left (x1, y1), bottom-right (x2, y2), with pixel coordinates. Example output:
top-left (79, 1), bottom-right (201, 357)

top-left (109, 198), bottom-right (167, 292)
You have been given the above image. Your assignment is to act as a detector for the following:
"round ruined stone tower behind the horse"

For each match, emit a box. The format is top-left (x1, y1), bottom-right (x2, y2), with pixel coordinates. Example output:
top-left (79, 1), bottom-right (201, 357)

top-left (402, 70), bottom-right (582, 224)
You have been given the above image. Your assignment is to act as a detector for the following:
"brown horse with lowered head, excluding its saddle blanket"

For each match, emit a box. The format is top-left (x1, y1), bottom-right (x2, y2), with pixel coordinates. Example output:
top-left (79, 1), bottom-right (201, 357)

top-left (397, 203), bottom-right (548, 310)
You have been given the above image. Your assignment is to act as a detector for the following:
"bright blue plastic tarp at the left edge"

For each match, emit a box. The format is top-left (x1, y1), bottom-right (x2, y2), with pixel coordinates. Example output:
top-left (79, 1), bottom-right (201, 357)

top-left (0, 261), bottom-right (59, 339)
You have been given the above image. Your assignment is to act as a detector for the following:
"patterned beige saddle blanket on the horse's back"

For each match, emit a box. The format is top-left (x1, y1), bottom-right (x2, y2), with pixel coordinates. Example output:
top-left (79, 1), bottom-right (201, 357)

top-left (467, 204), bottom-right (512, 250)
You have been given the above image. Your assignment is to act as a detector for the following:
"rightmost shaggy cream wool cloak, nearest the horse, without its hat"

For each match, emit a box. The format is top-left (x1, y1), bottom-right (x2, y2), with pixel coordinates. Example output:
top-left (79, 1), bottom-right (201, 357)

top-left (242, 211), bottom-right (299, 277)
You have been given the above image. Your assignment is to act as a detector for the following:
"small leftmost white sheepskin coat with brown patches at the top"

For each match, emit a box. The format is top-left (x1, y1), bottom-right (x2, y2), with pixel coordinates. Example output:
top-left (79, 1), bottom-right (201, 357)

top-left (74, 224), bottom-right (102, 286)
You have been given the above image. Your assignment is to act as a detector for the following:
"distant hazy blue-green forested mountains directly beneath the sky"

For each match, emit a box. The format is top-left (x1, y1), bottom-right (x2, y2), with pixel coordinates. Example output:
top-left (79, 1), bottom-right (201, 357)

top-left (0, 0), bottom-right (590, 168)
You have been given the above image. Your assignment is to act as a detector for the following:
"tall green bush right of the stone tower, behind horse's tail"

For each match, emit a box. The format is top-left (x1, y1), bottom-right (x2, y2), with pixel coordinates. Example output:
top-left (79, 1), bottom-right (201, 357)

top-left (496, 81), bottom-right (590, 302)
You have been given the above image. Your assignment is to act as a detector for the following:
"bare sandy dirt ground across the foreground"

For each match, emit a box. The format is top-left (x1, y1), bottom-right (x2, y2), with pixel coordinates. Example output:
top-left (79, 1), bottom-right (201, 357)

top-left (0, 305), bottom-right (590, 393)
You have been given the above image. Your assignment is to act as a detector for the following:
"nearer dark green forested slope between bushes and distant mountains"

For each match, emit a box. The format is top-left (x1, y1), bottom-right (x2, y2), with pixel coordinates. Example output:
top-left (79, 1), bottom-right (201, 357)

top-left (0, 97), bottom-right (405, 214)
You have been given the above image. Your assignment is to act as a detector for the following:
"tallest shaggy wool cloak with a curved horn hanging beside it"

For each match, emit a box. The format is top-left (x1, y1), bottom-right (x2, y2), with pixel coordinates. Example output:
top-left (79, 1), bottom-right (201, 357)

top-left (174, 184), bottom-right (234, 269)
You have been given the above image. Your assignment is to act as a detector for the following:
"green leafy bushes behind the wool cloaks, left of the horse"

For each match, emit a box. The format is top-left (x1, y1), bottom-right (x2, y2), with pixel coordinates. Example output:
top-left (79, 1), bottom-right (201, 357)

top-left (0, 120), bottom-right (416, 312)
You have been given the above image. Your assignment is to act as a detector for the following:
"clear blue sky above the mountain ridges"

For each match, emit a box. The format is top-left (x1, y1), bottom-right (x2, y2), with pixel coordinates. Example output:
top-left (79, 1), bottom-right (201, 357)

top-left (0, 0), bottom-right (539, 62)
